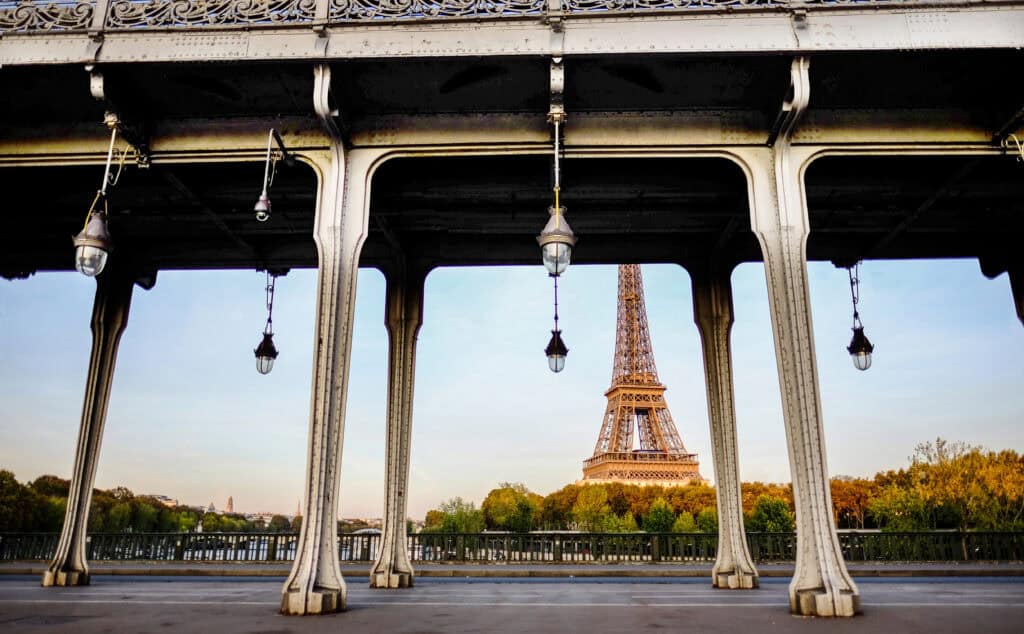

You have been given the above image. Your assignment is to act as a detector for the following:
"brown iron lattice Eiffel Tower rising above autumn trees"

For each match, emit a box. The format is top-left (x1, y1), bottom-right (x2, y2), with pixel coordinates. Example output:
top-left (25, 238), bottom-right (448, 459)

top-left (581, 264), bottom-right (703, 487)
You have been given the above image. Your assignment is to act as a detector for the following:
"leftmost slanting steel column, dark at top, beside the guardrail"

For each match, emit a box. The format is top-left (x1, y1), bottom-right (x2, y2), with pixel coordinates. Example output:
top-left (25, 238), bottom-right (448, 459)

top-left (42, 262), bottom-right (134, 586)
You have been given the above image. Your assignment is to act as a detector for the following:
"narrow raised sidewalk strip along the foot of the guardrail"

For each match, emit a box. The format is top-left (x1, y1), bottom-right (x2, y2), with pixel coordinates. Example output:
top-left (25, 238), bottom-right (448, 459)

top-left (0, 561), bottom-right (1024, 579)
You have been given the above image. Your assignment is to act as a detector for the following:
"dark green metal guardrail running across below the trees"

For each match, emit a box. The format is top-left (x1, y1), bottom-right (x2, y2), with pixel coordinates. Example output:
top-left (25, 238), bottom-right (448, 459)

top-left (0, 532), bottom-right (1024, 563)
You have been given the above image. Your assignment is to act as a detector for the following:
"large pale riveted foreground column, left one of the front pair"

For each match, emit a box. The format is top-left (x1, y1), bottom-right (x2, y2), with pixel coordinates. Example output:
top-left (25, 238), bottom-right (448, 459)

top-left (281, 66), bottom-right (376, 615)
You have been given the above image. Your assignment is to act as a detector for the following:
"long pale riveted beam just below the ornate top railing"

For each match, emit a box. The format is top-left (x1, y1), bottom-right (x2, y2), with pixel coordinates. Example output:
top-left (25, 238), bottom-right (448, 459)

top-left (6, 2), bottom-right (1024, 66)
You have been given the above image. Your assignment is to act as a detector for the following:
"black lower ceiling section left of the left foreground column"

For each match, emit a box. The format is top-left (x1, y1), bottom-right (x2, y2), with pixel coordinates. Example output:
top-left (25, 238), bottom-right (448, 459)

top-left (0, 163), bottom-right (316, 274)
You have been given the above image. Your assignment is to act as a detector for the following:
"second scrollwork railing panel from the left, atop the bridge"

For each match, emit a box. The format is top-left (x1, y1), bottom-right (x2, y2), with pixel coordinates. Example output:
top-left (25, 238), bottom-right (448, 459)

top-left (106, 0), bottom-right (316, 29)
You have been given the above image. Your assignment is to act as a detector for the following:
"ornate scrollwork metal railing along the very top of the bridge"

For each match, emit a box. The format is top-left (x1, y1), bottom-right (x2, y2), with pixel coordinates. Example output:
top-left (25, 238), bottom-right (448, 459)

top-left (0, 0), bottom-right (983, 34)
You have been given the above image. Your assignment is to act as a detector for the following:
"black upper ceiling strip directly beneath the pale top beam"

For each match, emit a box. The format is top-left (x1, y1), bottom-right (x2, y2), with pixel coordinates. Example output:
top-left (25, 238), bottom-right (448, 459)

top-left (0, 50), bottom-right (1024, 136)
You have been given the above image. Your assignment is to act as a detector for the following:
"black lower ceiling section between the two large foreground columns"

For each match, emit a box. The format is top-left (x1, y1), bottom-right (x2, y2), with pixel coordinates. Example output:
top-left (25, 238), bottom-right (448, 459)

top-left (371, 157), bottom-right (758, 264)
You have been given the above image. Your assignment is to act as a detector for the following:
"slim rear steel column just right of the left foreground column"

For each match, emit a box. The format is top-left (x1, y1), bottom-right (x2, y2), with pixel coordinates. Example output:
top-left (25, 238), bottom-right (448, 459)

top-left (370, 262), bottom-right (426, 588)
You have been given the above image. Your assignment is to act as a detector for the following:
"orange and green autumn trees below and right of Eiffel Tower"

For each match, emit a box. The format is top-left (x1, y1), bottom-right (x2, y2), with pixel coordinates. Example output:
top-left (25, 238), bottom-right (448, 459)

top-left (424, 438), bottom-right (1024, 533)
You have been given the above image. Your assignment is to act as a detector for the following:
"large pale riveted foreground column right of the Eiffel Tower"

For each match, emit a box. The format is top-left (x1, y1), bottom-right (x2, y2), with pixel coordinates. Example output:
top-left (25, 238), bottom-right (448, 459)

top-left (750, 58), bottom-right (859, 617)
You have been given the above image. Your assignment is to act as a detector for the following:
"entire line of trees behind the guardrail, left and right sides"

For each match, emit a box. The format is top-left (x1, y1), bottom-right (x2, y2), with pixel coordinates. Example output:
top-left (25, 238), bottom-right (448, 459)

top-left (0, 438), bottom-right (1024, 533)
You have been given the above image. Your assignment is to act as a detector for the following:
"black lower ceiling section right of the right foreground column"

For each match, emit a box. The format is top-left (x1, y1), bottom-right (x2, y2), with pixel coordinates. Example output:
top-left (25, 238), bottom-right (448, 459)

top-left (807, 156), bottom-right (1024, 261)
